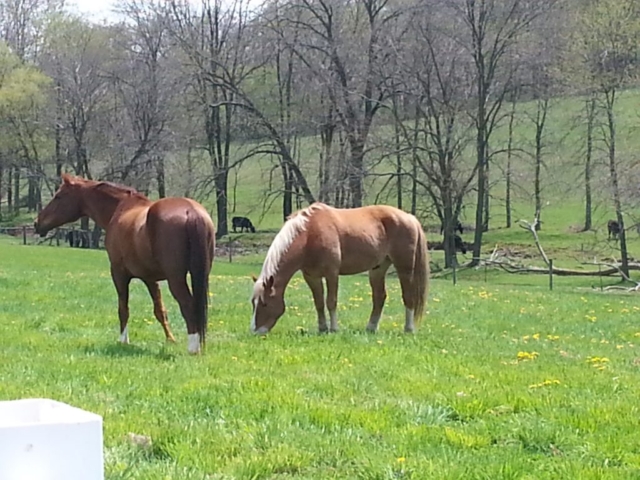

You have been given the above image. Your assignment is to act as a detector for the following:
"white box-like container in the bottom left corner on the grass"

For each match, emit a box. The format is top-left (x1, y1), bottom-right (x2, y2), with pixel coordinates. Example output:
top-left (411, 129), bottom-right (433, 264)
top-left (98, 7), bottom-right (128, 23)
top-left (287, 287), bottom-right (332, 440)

top-left (0, 398), bottom-right (104, 480)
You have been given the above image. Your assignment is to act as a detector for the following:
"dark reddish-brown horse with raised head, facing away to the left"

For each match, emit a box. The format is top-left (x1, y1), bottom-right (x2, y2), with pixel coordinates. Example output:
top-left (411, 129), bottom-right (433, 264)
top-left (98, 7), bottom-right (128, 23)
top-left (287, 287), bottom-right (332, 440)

top-left (35, 175), bottom-right (215, 353)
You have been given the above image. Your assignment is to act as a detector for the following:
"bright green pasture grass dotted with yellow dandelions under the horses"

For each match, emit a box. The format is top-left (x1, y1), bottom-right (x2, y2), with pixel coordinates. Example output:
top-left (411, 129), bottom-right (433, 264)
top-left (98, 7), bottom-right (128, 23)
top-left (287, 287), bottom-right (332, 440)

top-left (0, 237), bottom-right (640, 480)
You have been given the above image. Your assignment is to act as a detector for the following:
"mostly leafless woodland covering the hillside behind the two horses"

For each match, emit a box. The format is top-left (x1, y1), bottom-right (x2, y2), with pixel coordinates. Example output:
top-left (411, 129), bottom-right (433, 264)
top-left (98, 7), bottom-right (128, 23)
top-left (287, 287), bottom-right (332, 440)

top-left (0, 0), bottom-right (640, 269)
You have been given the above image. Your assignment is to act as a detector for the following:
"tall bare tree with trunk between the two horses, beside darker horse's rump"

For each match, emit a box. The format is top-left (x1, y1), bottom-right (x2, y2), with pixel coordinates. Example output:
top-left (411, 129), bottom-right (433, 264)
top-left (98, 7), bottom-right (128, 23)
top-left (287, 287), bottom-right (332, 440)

top-left (169, 0), bottom-right (288, 236)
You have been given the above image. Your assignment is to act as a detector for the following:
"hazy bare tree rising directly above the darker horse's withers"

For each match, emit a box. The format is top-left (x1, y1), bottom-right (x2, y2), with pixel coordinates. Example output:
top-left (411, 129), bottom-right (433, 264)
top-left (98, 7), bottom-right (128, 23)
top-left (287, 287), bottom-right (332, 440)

top-left (110, 0), bottom-right (177, 198)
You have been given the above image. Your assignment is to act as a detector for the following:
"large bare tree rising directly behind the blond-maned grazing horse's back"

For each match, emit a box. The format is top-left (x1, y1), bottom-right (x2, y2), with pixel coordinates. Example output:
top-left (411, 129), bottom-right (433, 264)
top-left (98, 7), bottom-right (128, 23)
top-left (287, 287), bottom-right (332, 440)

top-left (282, 0), bottom-right (404, 206)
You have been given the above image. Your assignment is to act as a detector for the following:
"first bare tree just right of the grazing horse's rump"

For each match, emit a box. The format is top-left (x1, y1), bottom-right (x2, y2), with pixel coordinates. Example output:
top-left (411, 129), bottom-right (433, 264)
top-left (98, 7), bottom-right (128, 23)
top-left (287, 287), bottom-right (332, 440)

top-left (396, 15), bottom-right (478, 267)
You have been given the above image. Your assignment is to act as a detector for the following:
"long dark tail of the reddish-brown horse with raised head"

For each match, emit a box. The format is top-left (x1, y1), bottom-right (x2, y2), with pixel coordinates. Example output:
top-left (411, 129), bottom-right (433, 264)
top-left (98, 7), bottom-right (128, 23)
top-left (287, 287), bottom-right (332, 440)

top-left (187, 211), bottom-right (215, 346)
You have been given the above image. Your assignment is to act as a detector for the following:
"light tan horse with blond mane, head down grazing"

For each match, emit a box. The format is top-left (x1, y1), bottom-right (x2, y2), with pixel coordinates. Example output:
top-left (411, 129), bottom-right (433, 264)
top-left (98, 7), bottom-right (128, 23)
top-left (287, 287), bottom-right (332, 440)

top-left (251, 203), bottom-right (429, 334)
